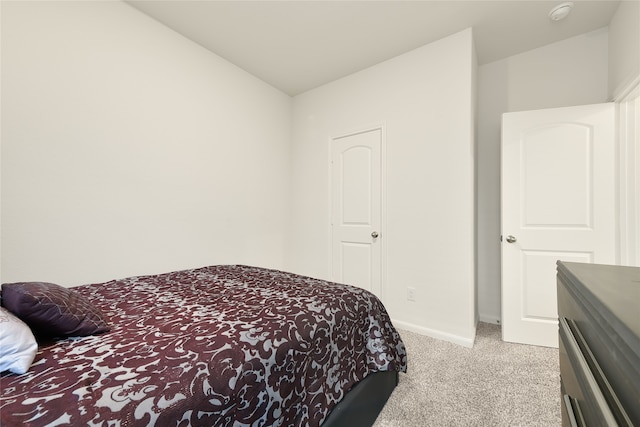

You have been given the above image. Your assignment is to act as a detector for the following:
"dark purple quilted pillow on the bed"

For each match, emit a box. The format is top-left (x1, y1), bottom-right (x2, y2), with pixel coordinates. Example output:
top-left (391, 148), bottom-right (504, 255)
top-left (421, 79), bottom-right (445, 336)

top-left (2, 282), bottom-right (109, 338)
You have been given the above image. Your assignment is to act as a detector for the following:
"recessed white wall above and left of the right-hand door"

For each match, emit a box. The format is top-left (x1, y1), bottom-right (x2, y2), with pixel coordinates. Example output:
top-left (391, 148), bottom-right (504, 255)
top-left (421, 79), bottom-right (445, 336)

top-left (477, 28), bottom-right (608, 322)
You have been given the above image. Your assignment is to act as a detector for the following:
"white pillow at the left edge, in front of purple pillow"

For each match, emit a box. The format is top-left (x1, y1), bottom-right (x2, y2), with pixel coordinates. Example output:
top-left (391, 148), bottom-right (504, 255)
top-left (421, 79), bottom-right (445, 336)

top-left (0, 307), bottom-right (38, 374)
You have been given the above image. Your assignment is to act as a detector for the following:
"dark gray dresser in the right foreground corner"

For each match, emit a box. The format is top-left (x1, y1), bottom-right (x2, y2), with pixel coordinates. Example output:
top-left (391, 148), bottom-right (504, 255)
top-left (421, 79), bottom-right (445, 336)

top-left (558, 261), bottom-right (640, 427)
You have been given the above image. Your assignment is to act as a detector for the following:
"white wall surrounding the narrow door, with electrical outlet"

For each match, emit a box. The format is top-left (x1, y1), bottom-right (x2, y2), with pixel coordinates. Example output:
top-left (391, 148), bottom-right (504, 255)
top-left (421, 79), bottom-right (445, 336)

top-left (288, 30), bottom-right (475, 344)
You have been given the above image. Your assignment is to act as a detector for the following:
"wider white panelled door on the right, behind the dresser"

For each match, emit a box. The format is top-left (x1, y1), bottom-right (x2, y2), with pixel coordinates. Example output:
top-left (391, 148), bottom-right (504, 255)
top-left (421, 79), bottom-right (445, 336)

top-left (501, 103), bottom-right (616, 347)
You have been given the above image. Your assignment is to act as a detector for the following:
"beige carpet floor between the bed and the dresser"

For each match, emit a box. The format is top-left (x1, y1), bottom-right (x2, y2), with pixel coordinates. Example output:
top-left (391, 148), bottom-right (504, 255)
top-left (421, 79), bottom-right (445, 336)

top-left (374, 323), bottom-right (561, 427)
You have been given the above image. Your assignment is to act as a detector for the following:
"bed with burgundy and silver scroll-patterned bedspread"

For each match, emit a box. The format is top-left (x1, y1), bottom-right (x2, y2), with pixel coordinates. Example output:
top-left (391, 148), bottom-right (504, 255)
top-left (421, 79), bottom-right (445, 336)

top-left (0, 265), bottom-right (407, 426)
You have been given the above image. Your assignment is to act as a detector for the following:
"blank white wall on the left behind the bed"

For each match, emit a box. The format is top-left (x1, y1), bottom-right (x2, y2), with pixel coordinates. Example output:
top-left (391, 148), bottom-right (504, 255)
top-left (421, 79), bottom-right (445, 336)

top-left (1, 2), bottom-right (291, 285)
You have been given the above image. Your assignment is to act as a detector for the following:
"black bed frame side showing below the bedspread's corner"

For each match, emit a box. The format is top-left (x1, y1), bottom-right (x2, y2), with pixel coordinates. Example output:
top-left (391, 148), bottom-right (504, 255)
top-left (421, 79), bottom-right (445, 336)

top-left (322, 371), bottom-right (398, 427)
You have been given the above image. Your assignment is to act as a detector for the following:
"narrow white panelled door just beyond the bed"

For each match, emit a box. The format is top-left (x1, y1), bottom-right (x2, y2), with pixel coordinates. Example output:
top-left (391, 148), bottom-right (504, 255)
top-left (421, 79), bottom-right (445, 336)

top-left (331, 128), bottom-right (382, 297)
